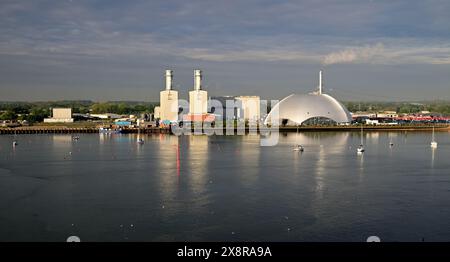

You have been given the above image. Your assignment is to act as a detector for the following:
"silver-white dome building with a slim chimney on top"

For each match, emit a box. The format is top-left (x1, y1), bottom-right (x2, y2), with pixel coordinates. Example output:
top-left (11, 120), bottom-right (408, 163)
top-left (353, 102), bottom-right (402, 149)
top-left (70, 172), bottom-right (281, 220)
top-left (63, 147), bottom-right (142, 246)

top-left (264, 71), bottom-right (352, 125)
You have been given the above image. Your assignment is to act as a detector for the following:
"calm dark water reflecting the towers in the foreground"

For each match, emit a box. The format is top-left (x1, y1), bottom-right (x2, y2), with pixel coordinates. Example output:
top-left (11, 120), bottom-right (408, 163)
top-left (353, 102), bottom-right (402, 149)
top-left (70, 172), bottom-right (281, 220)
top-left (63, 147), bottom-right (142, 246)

top-left (0, 132), bottom-right (450, 241)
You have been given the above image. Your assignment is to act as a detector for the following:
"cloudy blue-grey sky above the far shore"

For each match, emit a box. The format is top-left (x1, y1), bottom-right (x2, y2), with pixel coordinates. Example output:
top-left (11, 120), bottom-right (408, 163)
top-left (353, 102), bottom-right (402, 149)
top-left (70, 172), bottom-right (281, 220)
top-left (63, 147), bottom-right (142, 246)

top-left (0, 0), bottom-right (450, 101)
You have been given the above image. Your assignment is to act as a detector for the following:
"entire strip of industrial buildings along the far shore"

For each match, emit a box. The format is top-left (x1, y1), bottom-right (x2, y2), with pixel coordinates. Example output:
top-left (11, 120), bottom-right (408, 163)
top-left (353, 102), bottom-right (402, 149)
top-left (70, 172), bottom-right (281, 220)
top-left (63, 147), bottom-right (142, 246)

top-left (0, 69), bottom-right (450, 130)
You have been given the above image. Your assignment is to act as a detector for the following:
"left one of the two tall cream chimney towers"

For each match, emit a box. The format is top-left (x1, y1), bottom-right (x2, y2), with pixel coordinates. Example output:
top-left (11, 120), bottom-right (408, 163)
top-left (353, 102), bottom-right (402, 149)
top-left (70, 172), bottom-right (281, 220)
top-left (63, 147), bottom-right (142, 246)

top-left (159, 70), bottom-right (178, 122)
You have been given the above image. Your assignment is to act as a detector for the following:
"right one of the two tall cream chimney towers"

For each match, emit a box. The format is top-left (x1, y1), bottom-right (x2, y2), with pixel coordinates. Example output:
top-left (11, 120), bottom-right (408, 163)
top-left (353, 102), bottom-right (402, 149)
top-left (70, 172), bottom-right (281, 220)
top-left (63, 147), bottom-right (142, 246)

top-left (189, 69), bottom-right (208, 115)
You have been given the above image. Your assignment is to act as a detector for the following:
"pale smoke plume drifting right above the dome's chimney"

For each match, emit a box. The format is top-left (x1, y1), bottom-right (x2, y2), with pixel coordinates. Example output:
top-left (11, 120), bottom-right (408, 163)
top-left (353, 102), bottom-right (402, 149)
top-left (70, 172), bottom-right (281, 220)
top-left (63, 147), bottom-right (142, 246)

top-left (323, 43), bottom-right (384, 65)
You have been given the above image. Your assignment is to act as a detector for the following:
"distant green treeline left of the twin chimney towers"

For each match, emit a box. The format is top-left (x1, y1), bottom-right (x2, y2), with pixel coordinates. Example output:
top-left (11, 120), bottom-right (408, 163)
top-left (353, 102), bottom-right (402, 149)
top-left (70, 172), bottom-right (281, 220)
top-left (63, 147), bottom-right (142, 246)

top-left (0, 101), bottom-right (158, 123)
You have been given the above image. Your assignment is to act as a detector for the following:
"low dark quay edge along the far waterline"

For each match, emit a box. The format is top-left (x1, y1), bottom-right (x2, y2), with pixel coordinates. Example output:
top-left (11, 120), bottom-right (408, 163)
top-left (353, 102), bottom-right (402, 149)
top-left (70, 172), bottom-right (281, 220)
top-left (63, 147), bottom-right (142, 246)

top-left (0, 124), bottom-right (450, 135)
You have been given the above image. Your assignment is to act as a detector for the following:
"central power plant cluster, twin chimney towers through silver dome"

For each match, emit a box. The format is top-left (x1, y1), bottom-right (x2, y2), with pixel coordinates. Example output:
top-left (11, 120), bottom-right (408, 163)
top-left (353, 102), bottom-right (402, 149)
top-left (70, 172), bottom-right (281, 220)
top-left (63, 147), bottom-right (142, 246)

top-left (149, 69), bottom-right (352, 128)
